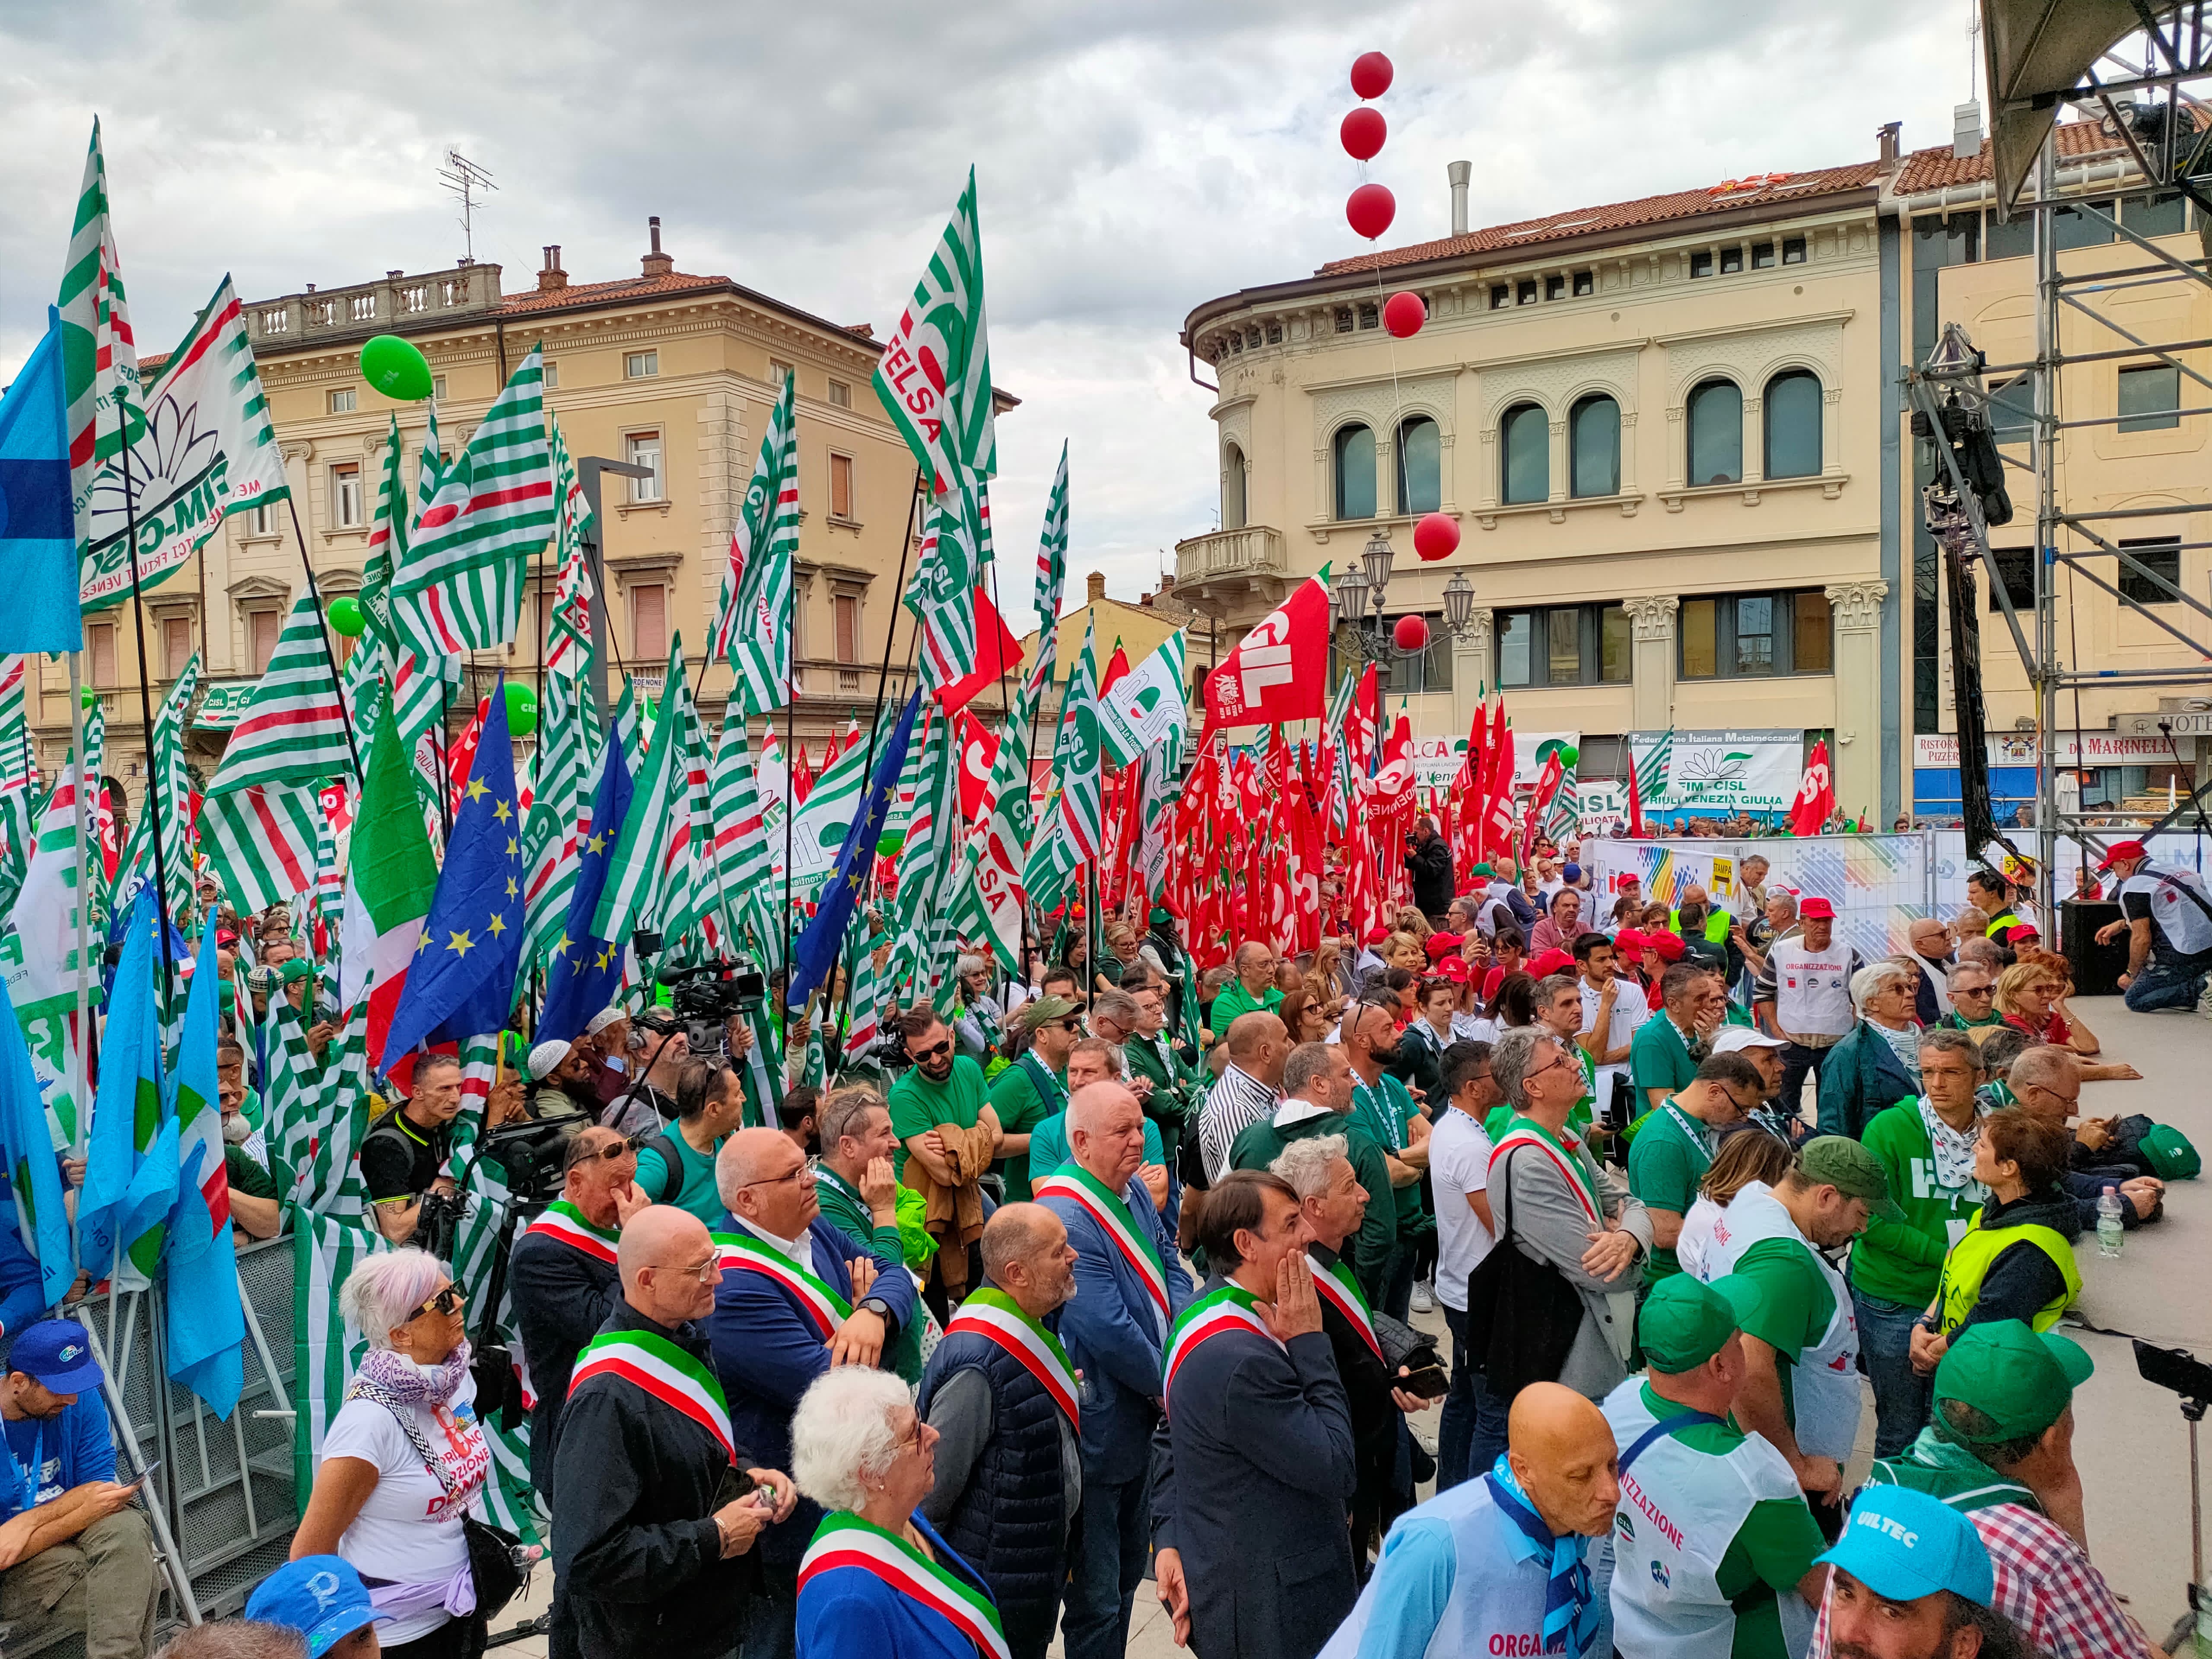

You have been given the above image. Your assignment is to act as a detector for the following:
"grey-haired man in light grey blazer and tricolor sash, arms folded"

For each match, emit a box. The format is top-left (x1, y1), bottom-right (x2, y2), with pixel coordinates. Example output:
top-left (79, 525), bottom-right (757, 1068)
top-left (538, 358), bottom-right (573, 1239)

top-left (1489, 1027), bottom-right (1653, 1400)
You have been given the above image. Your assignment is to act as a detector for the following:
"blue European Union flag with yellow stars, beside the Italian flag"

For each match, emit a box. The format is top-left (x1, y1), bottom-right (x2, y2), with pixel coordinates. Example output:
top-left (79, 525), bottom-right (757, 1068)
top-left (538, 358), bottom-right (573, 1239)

top-left (385, 675), bottom-right (527, 1057)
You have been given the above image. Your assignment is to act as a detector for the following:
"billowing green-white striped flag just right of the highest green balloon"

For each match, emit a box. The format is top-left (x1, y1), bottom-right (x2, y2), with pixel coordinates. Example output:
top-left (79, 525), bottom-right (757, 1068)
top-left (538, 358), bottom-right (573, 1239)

top-left (391, 347), bottom-right (553, 655)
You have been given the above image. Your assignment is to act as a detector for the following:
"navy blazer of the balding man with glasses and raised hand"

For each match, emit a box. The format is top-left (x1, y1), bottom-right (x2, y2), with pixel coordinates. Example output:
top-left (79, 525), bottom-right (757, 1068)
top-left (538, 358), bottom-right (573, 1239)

top-left (706, 1214), bottom-right (918, 1568)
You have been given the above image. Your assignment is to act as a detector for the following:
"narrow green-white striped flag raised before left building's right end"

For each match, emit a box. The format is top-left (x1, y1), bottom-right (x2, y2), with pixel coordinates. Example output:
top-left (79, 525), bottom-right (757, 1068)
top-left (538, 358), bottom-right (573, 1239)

top-left (706, 374), bottom-right (798, 715)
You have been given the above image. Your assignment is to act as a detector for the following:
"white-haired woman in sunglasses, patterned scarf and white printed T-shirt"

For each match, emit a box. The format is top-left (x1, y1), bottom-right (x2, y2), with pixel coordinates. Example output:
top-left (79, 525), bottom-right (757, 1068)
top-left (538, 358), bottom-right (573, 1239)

top-left (292, 1250), bottom-right (491, 1659)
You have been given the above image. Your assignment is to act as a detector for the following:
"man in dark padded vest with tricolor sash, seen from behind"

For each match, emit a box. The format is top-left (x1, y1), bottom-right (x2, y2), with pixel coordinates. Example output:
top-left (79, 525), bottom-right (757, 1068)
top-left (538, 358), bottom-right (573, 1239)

top-left (916, 1203), bottom-right (1084, 1659)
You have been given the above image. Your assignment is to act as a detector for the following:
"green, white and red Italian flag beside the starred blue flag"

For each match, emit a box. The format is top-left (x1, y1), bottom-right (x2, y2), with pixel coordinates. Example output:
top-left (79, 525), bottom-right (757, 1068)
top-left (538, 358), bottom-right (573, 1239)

top-left (338, 697), bottom-right (438, 1075)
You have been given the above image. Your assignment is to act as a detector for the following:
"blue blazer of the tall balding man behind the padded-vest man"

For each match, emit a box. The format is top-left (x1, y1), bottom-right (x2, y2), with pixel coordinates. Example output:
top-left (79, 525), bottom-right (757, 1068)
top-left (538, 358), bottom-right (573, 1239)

top-left (1039, 1177), bottom-right (1190, 1487)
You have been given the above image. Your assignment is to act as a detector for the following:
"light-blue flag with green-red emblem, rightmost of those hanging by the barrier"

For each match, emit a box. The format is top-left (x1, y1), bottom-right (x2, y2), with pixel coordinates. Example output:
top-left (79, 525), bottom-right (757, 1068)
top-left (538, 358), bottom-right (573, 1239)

top-left (168, 927), bottom-right (245, 1420)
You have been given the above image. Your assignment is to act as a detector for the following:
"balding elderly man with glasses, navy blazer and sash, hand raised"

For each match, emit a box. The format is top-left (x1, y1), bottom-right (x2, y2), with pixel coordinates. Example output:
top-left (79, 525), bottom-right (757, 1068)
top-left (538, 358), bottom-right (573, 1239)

top-left (708, 1132), bottom-right (915, 1659)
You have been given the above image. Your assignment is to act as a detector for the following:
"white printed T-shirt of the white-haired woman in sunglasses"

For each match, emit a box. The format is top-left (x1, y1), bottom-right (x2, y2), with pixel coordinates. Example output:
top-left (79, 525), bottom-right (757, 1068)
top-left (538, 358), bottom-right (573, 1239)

top-left (323, 1376), bottom-right (491, 1646)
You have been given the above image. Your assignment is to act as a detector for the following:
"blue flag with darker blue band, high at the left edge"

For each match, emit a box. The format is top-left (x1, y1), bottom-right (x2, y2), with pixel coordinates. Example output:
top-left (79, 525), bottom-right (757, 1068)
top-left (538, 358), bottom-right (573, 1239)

top-left (0, 305), bottom-right (84, 652)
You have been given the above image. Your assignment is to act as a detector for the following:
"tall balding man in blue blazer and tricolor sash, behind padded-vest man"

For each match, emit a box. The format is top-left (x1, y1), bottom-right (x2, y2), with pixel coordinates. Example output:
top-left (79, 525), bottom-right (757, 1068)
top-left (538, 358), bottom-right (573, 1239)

top-left (1033, 1084), bottom-right (1190, 1659)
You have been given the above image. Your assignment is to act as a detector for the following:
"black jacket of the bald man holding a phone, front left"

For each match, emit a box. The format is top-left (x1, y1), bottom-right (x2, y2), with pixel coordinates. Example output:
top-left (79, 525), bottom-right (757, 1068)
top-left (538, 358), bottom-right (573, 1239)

top-left (551, 1303), bottom-right (759, 1659)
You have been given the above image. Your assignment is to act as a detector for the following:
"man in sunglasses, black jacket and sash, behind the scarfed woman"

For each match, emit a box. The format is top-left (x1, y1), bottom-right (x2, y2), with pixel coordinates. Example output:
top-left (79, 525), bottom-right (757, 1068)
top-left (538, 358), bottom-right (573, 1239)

top-left (506, 1128), bottom-right (646, 1491)
